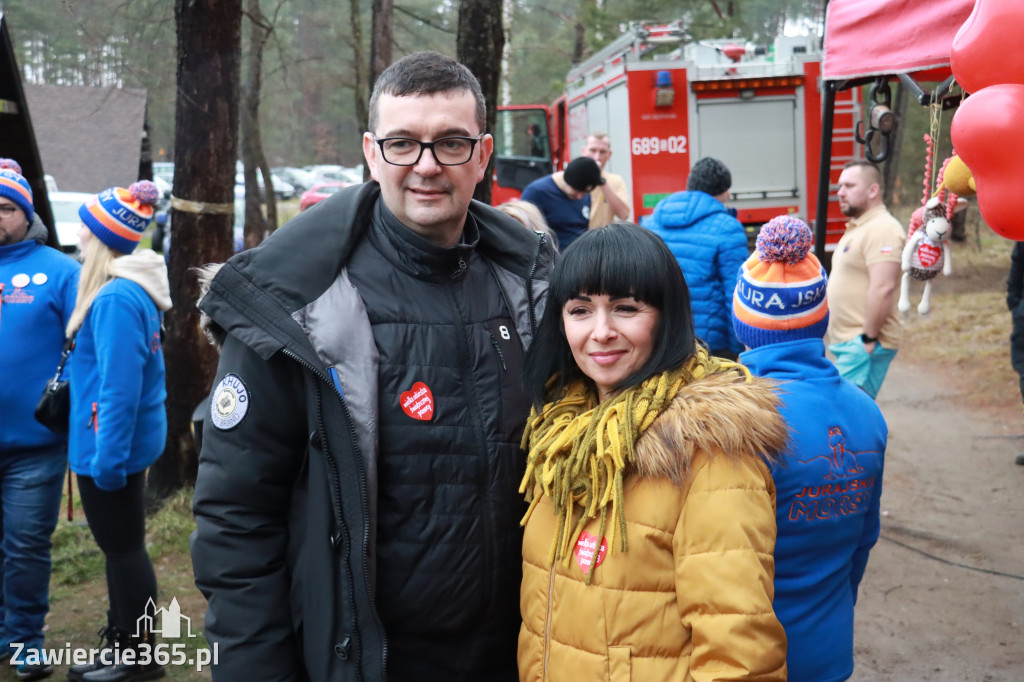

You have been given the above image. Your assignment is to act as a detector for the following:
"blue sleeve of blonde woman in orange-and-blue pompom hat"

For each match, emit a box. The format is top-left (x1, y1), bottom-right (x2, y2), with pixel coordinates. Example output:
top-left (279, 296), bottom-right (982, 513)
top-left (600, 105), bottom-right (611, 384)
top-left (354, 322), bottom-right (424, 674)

top-left (89, 296), bottom-right (150, 491)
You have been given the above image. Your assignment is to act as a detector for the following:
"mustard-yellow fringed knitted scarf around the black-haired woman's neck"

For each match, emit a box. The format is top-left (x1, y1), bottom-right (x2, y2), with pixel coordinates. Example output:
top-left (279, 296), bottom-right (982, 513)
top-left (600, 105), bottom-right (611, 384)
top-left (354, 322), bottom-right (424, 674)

top-left (519, 347), bottom-right (750, 585)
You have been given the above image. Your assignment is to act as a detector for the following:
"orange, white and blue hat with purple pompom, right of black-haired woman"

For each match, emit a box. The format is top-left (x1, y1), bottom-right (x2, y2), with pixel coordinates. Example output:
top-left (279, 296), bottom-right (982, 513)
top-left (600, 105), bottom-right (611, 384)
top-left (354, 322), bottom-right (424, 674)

top-left (732, 215), bottom-right (828, 348)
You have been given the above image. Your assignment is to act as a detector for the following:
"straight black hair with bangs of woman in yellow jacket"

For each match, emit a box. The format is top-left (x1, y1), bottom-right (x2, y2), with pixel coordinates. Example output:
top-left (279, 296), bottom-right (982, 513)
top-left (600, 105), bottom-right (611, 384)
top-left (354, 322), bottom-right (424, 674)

top-left (523, 222), bottom-right (696, 408)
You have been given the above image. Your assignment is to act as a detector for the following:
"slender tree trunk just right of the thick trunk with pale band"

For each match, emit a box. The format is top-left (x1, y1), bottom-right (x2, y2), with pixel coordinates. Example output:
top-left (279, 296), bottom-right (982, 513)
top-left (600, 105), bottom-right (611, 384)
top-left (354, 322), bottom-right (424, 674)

top-left (239, 0), bottom-right (278, 249)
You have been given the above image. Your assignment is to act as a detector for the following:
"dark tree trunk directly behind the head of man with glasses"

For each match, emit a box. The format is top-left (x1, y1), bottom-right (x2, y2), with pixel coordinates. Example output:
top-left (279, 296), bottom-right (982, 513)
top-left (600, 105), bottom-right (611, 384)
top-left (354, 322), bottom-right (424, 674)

top-left (456, 0), bottom-right (505, 204)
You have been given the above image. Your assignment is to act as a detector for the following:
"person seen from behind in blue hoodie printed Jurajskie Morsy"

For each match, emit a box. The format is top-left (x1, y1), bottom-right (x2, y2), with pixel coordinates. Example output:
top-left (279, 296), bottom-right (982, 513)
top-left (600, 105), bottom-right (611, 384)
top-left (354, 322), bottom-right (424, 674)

top-left (732, 216), bottom-right (888, 682)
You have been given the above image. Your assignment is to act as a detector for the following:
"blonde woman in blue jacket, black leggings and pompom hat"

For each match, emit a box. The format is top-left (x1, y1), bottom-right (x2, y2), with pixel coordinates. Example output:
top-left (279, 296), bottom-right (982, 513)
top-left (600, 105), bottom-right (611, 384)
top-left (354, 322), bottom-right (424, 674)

top-left (67, 180), bottom-right (171, 682)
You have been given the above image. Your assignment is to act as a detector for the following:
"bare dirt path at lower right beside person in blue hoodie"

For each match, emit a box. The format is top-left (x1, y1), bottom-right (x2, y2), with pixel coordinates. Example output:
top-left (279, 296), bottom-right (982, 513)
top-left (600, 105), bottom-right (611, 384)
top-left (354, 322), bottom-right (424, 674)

top-left (851, 356), bottom-right (1024, 682)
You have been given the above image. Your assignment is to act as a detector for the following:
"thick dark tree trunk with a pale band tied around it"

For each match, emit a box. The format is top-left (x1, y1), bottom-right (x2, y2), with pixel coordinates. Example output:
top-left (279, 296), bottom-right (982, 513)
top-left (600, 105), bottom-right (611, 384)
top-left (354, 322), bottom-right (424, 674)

top-left (150, 0), bottom-right (242, 499)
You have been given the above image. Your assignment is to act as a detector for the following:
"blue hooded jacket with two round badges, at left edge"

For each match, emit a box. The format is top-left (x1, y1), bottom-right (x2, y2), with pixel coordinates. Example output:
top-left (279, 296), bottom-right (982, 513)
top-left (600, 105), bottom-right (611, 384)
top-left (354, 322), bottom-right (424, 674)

top-left (0, 222), bottom-right (80, 455)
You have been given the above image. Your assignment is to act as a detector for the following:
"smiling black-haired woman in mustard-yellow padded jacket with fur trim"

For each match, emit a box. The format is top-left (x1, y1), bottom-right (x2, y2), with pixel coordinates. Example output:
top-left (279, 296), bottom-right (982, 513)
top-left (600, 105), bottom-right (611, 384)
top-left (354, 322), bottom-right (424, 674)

top-left (519, 223), bottom-right (786, 682)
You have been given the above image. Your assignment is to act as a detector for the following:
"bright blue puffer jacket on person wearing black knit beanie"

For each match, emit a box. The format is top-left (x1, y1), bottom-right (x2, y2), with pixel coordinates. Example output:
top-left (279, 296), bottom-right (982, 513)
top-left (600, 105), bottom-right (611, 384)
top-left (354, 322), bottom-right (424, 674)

top-left (640, 191), bottom-right (750, 353)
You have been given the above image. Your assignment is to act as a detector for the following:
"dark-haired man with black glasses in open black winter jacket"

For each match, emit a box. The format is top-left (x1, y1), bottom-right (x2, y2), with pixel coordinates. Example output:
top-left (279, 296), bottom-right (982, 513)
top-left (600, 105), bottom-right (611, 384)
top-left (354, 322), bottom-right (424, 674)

top-left (193, 52), bottom-right (553, 682)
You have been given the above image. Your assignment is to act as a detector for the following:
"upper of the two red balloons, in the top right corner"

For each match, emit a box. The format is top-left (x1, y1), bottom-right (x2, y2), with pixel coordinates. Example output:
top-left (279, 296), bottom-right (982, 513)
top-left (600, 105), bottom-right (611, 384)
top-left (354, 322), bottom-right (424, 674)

top-left (949, 0), bottom-right (1024, 92)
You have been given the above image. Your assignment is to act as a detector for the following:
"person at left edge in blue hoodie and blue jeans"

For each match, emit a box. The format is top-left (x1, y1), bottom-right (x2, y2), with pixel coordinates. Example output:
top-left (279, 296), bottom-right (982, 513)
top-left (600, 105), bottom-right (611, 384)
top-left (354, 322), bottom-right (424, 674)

top-left (0, 159), bottom-right (79, 679)
